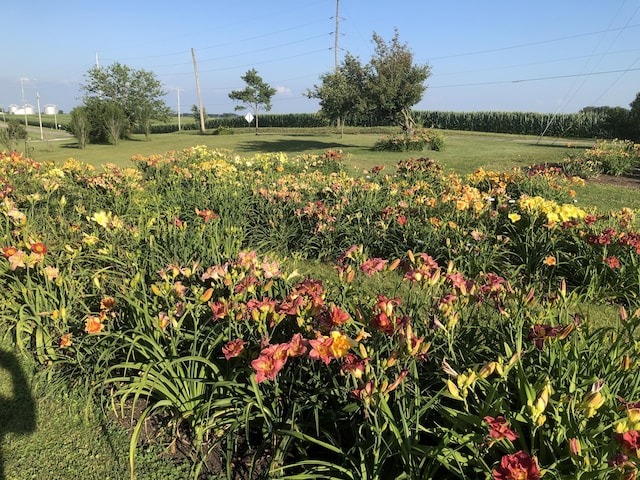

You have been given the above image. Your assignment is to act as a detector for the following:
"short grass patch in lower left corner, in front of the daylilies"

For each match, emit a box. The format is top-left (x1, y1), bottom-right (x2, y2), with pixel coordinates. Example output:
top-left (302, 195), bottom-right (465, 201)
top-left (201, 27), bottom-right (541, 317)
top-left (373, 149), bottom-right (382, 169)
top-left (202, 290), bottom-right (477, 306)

top-left (0, 342), bottom-right (189, 480)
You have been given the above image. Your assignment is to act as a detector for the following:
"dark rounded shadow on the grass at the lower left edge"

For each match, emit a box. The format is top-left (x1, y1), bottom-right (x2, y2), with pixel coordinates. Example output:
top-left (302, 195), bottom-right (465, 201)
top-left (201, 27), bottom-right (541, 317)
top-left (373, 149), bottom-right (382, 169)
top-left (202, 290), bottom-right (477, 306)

top-left (0, 349), bottom-right (36, 480)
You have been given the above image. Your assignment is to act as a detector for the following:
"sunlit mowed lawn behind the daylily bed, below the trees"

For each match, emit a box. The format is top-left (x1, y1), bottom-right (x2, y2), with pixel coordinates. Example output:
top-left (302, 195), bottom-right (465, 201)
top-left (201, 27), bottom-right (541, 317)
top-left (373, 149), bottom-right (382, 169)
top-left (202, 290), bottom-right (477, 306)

top-left (22, 124), bottom-right (640, 211)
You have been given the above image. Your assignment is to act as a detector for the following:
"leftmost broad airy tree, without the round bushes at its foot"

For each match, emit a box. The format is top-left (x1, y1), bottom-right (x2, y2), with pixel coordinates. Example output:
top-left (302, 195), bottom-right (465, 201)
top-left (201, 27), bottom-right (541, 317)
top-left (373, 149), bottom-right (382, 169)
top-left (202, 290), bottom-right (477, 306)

top-left (80, 62), bottom-right (171, 141)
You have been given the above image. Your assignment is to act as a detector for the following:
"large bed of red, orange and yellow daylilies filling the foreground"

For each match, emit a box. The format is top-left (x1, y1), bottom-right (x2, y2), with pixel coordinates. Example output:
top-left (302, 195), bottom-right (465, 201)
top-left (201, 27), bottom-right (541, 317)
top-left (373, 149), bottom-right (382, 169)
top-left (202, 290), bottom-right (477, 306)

top-left (0, 147), bottom-right (640, 479)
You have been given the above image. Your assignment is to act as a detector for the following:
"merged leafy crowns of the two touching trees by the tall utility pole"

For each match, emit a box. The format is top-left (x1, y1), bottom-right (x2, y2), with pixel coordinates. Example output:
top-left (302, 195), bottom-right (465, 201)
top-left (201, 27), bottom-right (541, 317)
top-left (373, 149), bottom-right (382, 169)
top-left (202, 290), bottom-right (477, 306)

top-left (307, 30), bottom-right (431, 132)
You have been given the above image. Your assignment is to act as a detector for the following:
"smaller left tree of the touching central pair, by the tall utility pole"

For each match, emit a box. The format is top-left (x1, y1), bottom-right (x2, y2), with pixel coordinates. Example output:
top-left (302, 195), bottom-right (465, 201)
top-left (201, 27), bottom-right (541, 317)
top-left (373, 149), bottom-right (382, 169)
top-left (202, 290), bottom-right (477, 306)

top-left (306, 53), bottom-right (365, 136)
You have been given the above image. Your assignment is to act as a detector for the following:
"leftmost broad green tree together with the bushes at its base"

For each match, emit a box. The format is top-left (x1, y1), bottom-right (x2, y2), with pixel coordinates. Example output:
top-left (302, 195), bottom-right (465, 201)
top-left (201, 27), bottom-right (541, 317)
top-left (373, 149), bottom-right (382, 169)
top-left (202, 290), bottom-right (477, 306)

top-left (80, 62), bottom-right (171, 143)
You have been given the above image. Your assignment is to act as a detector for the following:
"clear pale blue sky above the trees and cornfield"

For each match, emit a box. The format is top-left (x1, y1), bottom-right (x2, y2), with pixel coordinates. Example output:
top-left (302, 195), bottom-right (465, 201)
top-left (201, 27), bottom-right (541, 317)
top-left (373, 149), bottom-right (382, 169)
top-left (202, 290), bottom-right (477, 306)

top-left (0, 0), bottom-right (640, 113)
